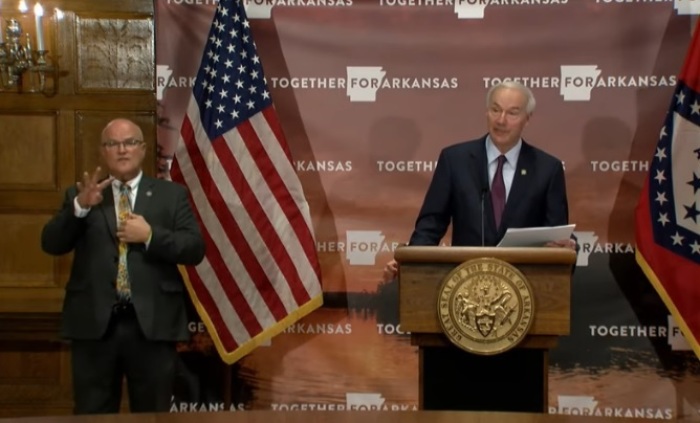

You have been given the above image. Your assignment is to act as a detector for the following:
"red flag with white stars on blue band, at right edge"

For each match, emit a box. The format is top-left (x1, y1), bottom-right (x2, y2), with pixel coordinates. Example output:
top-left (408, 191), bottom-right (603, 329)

top-left (635, 21), bottom-right (700, 357)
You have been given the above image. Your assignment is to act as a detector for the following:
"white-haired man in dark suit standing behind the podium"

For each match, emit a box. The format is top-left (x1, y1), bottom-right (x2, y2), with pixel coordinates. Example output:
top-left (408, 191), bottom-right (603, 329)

top-left (384, 81), bottom-right (576, 280)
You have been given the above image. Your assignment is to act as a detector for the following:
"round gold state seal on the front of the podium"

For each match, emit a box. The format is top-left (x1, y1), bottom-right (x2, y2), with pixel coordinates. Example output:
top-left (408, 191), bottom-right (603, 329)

top-left (437, 258), bottom-right (535, 355)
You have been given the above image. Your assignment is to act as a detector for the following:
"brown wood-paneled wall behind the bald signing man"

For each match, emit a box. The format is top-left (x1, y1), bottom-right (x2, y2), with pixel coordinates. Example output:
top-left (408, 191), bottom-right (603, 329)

top-left (0, 0), bottom-right (156, 417)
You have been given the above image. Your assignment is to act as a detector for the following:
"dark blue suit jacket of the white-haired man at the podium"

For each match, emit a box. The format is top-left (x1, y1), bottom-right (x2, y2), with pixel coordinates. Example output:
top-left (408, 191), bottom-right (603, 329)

top-left (409, 136), bottom-right (569, 246)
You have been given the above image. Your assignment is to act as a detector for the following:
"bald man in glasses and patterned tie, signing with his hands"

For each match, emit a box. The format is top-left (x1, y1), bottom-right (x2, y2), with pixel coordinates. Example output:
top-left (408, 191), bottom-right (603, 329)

top-left (41, 119), bottom-right (204, 414)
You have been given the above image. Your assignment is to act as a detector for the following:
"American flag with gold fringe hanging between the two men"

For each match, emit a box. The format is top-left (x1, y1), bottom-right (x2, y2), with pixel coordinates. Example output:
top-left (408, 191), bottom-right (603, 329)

top-left (170, 0), bottom-right (323, 364)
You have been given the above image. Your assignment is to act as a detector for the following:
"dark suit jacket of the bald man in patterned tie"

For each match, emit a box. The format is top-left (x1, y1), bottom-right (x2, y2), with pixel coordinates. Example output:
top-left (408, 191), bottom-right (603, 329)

top-left (41, 175), bottom-right (204, 341)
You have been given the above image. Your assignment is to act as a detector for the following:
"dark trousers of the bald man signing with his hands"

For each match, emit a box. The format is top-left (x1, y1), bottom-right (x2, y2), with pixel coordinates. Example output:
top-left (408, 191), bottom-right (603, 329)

top-left (71, 306), bottom-right (177, 414)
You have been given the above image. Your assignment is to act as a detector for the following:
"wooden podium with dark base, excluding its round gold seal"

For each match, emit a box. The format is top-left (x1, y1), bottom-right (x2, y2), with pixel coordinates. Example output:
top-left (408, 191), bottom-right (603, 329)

top-left (394, 246), bottom-right (576, 413)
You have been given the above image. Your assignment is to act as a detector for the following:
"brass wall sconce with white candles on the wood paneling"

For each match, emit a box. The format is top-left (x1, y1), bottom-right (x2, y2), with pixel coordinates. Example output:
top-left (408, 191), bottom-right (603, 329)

top-left (0, 3), bottom-right (58, 96)
